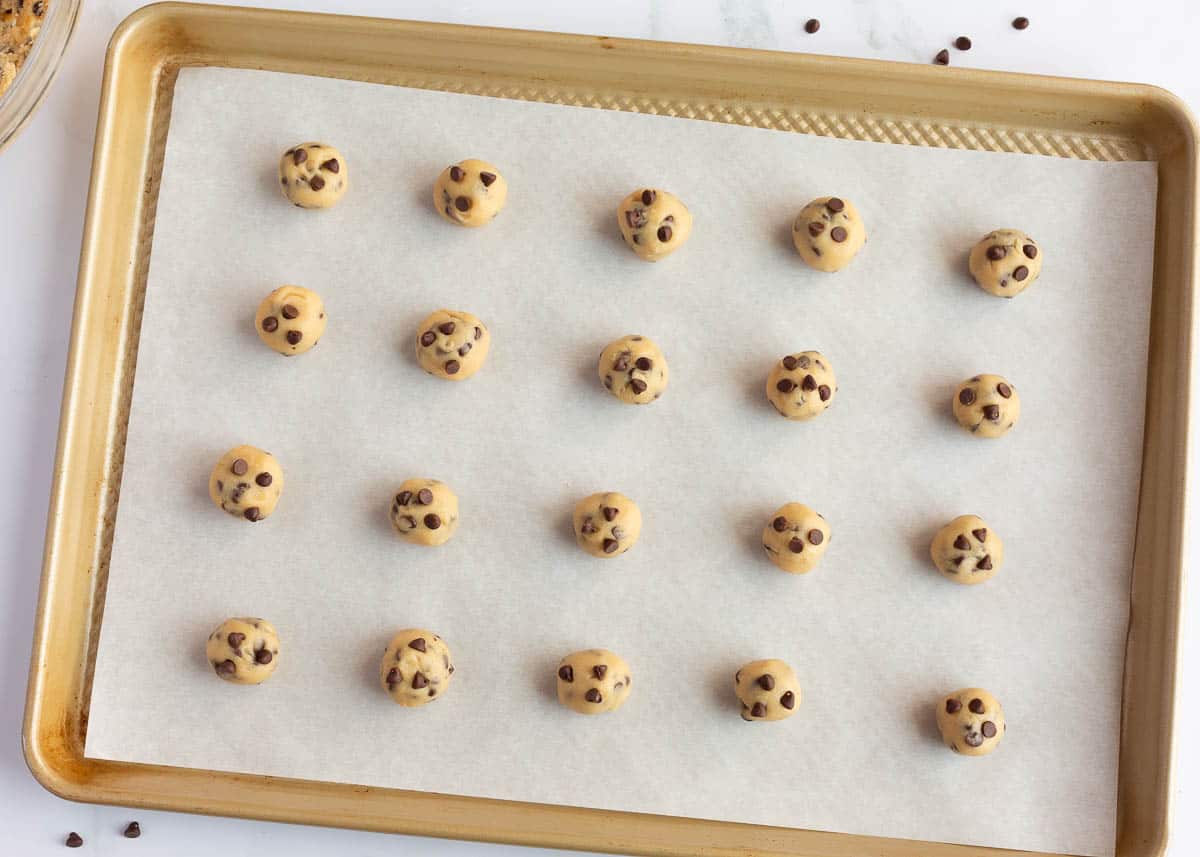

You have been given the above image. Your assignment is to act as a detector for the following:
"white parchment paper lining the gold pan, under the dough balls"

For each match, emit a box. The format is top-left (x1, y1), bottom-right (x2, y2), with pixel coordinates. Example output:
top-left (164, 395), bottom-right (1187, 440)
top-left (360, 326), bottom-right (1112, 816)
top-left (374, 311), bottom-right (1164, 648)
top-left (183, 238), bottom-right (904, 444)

top-left (86, 70), bottom-right (1156, 855)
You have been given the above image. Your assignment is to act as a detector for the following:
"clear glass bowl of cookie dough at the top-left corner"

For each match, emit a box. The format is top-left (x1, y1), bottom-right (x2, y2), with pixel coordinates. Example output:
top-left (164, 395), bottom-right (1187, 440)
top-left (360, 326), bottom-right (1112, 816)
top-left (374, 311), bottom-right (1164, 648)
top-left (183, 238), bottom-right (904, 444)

top-left (0, 0), bottom-right (80, 150)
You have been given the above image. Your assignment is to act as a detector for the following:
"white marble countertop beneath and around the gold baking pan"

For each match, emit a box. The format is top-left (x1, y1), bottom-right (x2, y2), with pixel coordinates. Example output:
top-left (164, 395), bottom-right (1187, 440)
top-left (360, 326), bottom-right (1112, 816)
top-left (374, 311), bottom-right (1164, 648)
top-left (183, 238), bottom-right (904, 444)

top-left (0, 0), bottom-right (1200, 857)
